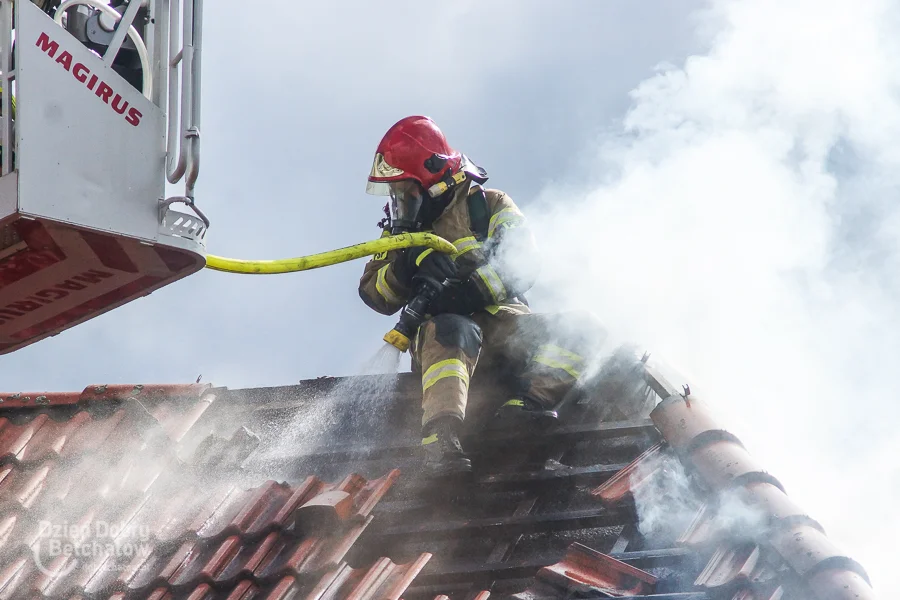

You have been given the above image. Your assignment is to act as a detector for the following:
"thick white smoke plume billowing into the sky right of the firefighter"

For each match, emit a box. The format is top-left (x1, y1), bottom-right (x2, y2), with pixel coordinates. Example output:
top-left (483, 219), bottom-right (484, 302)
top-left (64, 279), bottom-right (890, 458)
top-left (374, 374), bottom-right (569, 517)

top-left (529, 0), bottom-right (900, 589)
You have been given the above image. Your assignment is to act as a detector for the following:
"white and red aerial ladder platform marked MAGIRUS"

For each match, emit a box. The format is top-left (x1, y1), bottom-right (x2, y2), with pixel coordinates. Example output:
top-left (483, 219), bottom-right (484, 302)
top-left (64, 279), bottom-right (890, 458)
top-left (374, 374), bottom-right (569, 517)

top-left (0, 0), bottom-right (209, 354)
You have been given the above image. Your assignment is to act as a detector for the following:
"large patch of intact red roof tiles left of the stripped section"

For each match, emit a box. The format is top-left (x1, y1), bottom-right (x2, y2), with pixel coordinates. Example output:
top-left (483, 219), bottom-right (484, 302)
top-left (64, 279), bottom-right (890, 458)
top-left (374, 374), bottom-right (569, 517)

top-left (0, 385), bottom-right (430, 600)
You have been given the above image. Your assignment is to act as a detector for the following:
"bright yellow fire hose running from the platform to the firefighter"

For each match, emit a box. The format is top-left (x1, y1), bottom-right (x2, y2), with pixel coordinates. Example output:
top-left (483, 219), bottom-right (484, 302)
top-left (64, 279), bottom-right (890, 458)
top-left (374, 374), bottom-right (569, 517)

top-left (206, 233), bottom-right (456, 275)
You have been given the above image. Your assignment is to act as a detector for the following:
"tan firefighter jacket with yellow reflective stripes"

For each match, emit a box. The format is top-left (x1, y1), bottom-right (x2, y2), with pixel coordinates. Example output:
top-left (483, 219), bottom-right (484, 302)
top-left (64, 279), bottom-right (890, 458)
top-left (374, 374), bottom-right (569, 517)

top-left (359, 183), bottom-right (540, 315)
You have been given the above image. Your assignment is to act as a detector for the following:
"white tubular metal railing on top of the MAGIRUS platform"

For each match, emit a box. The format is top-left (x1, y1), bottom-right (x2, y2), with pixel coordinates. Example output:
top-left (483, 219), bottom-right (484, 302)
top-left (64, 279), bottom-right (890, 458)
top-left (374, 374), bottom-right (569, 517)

top-left (0, 0), bottom-right (209, 225)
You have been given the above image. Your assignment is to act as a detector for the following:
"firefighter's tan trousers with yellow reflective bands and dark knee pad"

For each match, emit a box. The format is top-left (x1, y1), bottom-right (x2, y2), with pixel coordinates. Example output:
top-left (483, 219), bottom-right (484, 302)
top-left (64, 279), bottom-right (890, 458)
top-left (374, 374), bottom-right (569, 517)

top-left (412, 305), bottom-right (605, 427)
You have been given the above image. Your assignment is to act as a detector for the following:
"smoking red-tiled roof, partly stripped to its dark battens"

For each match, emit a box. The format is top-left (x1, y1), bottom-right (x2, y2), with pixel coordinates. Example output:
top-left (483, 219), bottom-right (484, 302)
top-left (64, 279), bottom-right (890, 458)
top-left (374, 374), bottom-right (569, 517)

top-left (0, 356), bottom-right (874, 600)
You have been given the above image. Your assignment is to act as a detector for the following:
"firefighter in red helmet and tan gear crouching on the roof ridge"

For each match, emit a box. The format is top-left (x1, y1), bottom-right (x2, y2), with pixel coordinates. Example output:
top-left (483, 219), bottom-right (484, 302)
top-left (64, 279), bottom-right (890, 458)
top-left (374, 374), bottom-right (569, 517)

top-left (359, 116), bottom-right (598, 475)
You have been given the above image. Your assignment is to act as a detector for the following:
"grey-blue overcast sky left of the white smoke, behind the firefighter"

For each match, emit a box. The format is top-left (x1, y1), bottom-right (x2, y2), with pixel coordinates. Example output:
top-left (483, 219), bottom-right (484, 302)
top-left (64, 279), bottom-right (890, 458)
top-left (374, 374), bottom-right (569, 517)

top-left (3, 0), bottom-right (699, 390)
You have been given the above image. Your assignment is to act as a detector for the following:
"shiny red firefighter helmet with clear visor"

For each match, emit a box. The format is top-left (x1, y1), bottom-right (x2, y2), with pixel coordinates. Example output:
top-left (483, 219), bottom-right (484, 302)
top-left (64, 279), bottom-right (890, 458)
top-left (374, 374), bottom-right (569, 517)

top-left (366, 116), bottom-right (463, 196)
